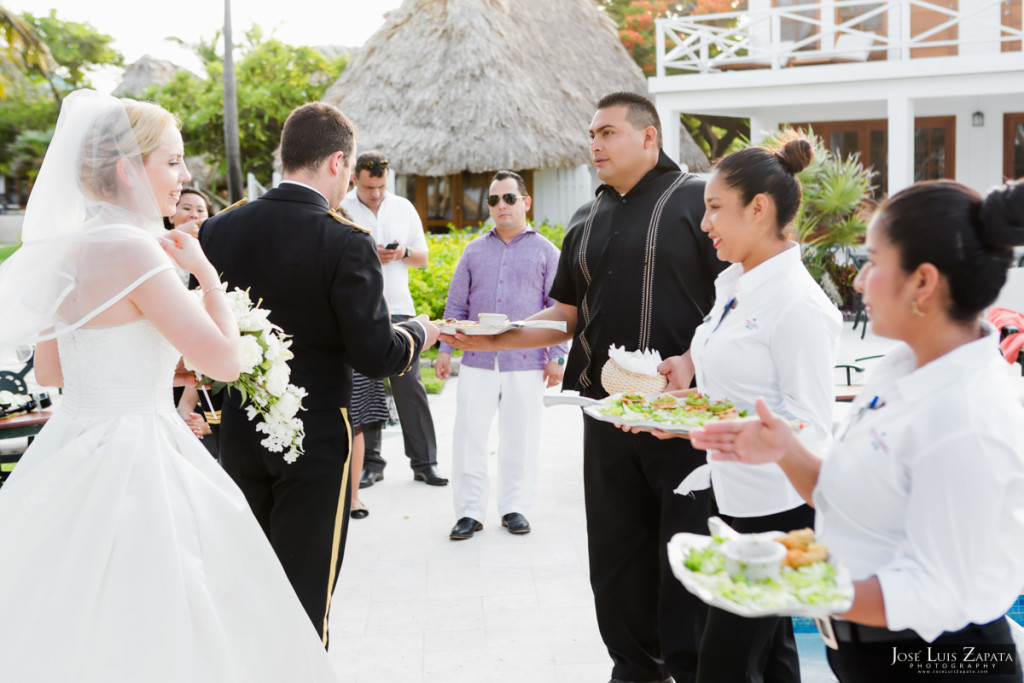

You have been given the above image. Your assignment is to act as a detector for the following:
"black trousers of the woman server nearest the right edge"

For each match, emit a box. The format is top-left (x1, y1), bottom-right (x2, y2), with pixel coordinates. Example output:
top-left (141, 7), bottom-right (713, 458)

top-left (825, 617), bottom-right (1022, 683)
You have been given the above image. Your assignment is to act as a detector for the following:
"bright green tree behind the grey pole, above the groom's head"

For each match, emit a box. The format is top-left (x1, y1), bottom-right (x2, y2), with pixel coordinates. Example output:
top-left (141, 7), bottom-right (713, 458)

top-left (142, 25), bottom-right (348, 196)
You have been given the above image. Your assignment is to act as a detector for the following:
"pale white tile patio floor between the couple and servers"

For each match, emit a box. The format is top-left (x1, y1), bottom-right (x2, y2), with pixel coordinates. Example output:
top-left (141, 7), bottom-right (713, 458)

top-left (323, 323), bottom-right (892, 683)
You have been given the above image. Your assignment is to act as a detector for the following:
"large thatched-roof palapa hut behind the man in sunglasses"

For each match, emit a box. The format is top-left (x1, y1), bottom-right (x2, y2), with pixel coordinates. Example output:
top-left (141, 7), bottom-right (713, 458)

top-left (324, 0), bottom-right (707, 230)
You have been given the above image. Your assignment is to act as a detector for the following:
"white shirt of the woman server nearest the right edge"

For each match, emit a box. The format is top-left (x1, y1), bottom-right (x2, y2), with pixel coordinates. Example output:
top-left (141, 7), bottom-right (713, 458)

top-left (814, 323), bottom-right (1024, 641)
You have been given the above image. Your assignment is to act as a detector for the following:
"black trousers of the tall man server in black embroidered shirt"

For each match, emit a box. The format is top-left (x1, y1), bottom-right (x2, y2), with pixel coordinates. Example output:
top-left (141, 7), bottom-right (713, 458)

top-left (584, 417), bottom-right (710, 683)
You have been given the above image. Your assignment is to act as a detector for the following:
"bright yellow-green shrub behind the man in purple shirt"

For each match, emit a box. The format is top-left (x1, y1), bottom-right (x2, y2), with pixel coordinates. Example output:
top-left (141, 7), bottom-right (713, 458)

top-left (409, 222), bottom-right (565, 321)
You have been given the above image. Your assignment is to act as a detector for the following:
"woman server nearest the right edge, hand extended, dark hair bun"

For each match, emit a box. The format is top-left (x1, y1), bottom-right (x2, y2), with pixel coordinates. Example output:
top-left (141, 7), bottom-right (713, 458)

top-left (693, 181), bottom-right (1024, 683)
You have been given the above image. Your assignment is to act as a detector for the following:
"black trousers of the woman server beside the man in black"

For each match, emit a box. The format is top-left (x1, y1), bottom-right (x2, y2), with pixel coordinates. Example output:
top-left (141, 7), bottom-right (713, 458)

top-left (697, 505), bottom-right (814, 683)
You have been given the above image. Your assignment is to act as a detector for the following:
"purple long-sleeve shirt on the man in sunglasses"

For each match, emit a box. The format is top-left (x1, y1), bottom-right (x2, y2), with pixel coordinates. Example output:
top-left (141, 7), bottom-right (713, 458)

top-left (440, 227), bottom-right (567, 373)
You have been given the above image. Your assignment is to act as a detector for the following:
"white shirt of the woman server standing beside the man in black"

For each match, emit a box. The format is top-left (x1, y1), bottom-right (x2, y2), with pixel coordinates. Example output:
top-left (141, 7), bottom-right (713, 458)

top-left (690, 244), bottom-right (843, 516)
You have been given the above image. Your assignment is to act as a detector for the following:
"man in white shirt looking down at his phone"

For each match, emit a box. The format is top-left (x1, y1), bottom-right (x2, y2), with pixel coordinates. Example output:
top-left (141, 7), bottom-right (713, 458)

top-left (341, 151), bottom-right (447, 488)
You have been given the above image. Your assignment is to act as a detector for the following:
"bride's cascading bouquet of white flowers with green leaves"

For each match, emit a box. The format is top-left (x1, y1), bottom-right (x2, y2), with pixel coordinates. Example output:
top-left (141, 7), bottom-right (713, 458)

top-left (184, 287), bottom-right (306, 464)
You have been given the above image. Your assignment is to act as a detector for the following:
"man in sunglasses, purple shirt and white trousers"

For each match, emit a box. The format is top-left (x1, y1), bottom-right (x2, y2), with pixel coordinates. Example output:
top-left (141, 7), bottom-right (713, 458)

top-left (434, 171), bottom-right (566, 541)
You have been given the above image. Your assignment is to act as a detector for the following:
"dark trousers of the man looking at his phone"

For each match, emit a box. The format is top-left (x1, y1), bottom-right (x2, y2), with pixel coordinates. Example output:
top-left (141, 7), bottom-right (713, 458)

top-left (362, 315), bottom-right (437, 472)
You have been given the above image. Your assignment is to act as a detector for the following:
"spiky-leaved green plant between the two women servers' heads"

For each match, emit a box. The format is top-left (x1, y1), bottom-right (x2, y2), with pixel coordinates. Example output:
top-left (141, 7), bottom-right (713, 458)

top-left (762, 130), bottom-right (874, 309)
